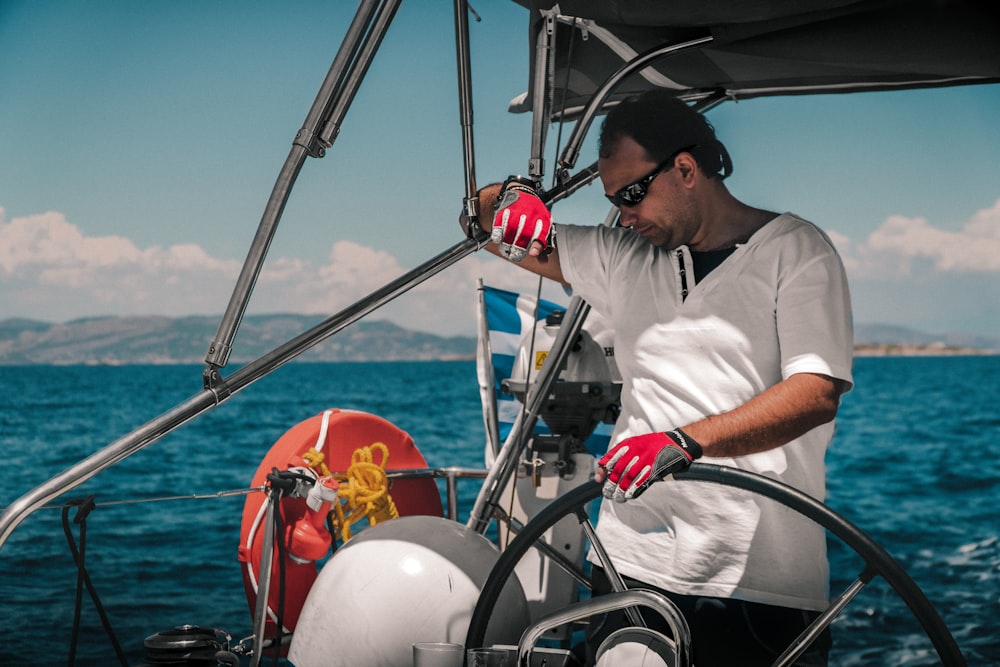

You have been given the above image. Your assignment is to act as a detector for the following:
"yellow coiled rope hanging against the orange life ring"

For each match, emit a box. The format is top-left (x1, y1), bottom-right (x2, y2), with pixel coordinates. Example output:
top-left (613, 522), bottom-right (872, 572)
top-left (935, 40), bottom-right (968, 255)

top-left (324, 442), bottom-right (399, 542)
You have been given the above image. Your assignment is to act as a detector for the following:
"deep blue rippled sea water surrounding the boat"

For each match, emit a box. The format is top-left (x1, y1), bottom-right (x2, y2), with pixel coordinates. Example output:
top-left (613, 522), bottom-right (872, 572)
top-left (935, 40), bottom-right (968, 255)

top-left (0, 357), bottom-right (1000, 667)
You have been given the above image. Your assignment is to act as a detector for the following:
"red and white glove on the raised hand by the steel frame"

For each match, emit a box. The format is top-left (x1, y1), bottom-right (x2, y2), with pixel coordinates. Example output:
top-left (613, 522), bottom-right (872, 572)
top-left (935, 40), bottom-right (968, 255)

top-left (490, 177), bottom-right (555, 262)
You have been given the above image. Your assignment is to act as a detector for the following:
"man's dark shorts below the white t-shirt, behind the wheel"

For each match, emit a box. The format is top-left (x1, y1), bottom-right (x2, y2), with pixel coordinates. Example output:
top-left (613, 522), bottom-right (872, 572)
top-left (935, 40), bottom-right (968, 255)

top-left (587, 567), bottom-right (832, 667)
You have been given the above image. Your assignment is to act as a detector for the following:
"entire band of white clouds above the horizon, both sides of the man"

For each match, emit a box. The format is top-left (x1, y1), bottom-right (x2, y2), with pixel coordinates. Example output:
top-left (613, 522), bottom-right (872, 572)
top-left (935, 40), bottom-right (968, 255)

top-left (0, 200), bottom-right (1000, 335)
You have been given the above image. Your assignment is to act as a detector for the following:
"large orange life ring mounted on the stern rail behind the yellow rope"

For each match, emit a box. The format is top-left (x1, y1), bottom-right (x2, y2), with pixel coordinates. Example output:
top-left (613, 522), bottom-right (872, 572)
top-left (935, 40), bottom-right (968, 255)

top-left (239, 409), bottom-right (444, 653)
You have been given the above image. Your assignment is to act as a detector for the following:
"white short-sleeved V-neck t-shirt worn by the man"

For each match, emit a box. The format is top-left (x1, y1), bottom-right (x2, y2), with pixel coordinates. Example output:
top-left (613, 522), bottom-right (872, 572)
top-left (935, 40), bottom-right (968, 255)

top-left (558, 214), bottom-right (853, 610)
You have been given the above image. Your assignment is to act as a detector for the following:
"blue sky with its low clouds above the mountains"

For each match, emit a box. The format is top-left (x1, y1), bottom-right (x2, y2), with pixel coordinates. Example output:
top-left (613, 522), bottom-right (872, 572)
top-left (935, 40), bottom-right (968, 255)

top-left (0, 0), bottom-right (1000, 344)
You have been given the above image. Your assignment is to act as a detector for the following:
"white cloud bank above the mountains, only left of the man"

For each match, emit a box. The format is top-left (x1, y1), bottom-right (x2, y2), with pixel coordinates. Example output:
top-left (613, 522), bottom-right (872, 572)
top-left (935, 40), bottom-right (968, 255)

top-left (0, 208), bottom-right (564, 335)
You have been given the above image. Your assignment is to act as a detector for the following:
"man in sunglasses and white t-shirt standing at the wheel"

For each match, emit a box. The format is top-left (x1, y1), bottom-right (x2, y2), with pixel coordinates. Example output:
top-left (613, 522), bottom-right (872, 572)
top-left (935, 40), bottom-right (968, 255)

top-left (468, 92), bottom-right (853, 667)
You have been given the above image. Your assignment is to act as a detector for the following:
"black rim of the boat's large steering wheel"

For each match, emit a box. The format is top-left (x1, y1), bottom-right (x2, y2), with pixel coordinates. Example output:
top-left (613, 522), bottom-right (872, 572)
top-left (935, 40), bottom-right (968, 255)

top-left (465, 463), bottom-right (966, 667)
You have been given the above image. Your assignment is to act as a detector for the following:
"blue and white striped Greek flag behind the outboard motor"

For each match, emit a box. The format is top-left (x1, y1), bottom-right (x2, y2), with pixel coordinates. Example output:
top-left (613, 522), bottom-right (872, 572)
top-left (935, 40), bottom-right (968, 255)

top-left (476, 284), bottom-right (613, 461)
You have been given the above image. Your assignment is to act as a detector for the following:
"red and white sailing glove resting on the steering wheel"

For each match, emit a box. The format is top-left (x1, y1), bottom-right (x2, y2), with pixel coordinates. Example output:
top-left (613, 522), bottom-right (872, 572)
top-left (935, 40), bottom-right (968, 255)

top-left (597, 428), bottom-right (702, 503)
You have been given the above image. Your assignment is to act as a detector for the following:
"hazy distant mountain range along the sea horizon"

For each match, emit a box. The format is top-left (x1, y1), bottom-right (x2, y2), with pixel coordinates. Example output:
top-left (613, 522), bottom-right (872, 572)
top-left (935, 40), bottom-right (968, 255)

top-left (0, 314), bottom-right (1000, 366)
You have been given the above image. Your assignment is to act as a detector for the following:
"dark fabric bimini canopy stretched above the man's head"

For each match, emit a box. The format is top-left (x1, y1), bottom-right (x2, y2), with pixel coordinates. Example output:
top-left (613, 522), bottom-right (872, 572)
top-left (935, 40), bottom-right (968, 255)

top-left (511, 0), bottom-right (1000, 117)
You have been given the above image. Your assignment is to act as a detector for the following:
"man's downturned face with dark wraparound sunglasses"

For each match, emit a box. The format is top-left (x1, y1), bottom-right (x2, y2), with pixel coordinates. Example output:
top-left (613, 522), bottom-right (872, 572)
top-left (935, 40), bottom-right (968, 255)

top-left (598, 136), bottom-right (699, 250)
